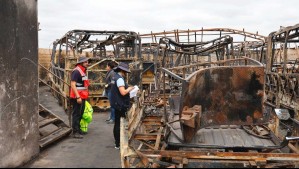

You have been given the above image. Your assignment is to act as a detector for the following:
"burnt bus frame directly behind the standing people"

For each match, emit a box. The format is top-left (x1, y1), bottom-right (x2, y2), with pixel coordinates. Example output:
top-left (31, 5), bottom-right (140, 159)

top-left (48, 30), bottom-right (147, 111)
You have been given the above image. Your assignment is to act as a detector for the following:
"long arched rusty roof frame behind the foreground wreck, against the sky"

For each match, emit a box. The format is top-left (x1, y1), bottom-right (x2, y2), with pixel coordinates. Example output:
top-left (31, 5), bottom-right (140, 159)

top-left (140, 28), bottom-right (267, 65)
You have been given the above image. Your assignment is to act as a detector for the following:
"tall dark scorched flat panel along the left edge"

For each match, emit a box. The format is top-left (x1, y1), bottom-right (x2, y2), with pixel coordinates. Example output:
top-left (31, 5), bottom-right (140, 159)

top-left (0, 0), bottom-right (39, 168)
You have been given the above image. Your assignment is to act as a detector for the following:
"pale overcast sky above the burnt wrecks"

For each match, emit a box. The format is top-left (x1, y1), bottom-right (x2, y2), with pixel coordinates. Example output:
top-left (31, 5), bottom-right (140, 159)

top-left (38, 0), bottom-right (299, 49)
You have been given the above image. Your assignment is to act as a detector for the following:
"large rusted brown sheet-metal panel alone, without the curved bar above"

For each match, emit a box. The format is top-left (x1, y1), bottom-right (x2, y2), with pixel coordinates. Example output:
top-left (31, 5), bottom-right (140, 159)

top-left (181, 66), bottom-right (265, 128)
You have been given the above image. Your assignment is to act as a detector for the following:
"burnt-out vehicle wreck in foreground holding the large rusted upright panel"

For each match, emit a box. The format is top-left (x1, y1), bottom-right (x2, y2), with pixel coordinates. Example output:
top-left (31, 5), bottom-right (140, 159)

top-left (121, 28), bottom-right (299, 168)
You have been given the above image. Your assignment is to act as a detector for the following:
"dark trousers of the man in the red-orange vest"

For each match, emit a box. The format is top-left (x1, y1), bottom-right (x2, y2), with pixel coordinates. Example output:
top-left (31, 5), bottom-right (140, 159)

top-left (71, 99), bottom-right (85, 133)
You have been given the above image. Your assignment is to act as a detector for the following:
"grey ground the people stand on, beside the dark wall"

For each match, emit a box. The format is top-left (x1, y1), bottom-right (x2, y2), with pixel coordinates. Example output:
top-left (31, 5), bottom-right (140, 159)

top-left (21, 87), bottom-right (121, 168)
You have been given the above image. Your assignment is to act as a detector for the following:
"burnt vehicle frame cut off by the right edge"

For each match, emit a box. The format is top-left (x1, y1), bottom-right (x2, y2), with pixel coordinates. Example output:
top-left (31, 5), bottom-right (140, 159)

top-left (265, 24), bottom-right (299, 153)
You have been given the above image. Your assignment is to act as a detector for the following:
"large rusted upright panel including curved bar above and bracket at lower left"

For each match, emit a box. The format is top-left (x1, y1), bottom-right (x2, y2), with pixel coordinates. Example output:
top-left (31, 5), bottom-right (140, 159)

top-left (162, 58), bottom-right (267, 142)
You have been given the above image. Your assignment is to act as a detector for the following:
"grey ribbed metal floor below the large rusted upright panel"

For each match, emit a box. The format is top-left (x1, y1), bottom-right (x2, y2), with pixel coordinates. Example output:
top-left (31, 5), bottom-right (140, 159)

top-left (168, 126), bottom-right (280, 150)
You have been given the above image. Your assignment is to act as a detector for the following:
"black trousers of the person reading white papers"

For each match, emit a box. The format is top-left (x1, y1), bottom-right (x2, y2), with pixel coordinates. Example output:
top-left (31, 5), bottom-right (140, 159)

top-left (113, 109), bottom-right (127, 147)
